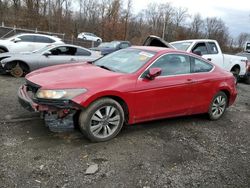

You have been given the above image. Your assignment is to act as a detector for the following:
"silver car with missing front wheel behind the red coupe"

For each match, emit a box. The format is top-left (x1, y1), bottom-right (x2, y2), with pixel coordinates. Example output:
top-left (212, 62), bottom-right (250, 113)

top-left (0, 44), bottom-right (101, 77)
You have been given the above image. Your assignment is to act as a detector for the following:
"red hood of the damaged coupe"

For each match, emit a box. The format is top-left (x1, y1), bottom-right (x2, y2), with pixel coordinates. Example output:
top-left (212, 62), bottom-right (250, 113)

top-left (26, 63), bottom-right (126, 89)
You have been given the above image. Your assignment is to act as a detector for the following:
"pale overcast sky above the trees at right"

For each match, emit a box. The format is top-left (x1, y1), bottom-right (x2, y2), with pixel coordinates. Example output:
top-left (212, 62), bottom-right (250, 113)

top-left (132, 0), bottom-right (250, 37)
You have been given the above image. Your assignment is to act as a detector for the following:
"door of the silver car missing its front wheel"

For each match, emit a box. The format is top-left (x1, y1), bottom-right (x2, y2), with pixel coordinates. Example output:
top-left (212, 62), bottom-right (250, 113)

top-left (39, 46), bottom-right (77, 68)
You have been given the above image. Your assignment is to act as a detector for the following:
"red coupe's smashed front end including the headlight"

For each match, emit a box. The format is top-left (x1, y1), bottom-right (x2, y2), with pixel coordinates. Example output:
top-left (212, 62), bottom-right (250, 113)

top-left (18, 80), bottom-right (84, 132)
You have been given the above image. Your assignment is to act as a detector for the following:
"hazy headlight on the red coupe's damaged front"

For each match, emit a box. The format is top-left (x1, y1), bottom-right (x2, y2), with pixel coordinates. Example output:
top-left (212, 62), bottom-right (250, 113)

top-left (36, 89), bottom-right (87, 99)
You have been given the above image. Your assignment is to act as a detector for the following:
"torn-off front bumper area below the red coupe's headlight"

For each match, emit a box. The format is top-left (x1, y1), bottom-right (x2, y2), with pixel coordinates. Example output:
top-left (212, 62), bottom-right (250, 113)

top-left (18, 85), bottom-right (80, 132)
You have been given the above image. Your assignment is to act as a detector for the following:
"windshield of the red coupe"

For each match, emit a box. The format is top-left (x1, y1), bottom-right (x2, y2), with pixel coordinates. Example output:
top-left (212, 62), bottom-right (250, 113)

top-left (94, 48), bottom-right (155, 73)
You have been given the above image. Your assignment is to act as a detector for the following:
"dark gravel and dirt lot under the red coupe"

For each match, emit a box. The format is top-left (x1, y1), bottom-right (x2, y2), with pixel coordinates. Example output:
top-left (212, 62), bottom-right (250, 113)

top-left (0, 76), bottom-right (250, 188)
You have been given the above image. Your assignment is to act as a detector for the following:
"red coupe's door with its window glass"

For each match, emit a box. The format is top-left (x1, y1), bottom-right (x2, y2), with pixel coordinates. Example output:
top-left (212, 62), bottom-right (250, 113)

top-left (135, 54), bottom-right (192, 121)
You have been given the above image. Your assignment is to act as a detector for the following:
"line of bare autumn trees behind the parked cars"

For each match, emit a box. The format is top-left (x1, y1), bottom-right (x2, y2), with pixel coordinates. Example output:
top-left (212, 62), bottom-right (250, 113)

top-left (0, 0), bottom-right (249, 51)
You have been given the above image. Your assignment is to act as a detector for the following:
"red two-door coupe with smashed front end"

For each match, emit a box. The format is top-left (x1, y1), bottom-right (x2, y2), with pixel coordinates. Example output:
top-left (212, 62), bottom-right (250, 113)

top-left (18, 46), bottom-right (237, 142)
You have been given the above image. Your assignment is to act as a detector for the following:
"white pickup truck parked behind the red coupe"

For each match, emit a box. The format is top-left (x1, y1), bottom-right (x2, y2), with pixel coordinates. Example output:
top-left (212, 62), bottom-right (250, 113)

top-left (170, 39), bottom-right (247, 79)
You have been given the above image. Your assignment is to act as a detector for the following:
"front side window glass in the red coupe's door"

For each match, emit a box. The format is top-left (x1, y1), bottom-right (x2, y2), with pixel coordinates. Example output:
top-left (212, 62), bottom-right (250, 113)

top-left (151, 54), bottom-right (191, 76)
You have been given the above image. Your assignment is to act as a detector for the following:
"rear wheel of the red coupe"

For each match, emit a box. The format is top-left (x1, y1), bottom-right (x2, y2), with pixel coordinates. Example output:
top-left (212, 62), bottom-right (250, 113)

top-left (208, 92), bottom-right (228, 120)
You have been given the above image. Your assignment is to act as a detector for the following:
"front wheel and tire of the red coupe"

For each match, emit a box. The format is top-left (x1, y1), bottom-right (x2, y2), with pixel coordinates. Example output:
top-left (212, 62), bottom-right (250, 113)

top-left (79, 98), bottom-right (124, 142)
